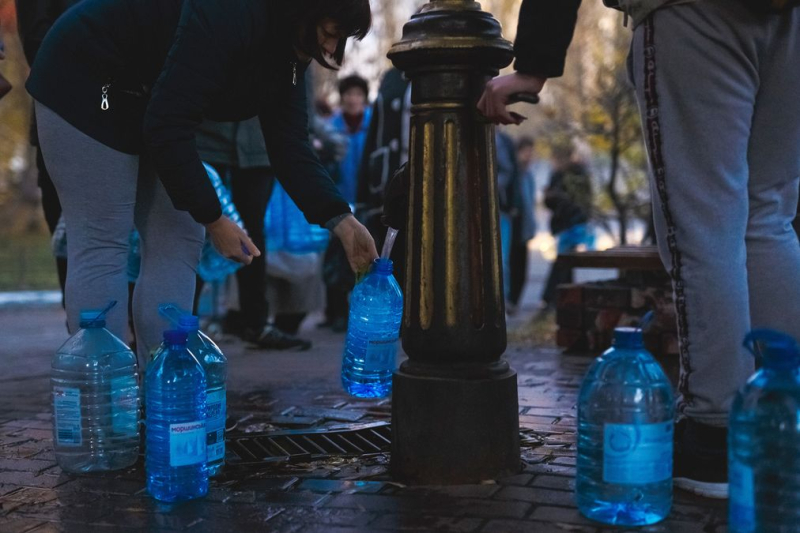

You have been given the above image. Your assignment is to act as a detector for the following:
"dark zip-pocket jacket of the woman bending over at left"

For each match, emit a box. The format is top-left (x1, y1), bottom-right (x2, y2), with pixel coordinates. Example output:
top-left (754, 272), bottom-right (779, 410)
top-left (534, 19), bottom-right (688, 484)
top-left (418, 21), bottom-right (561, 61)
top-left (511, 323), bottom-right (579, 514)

top-left (27, 0), bottom-right (349, 224)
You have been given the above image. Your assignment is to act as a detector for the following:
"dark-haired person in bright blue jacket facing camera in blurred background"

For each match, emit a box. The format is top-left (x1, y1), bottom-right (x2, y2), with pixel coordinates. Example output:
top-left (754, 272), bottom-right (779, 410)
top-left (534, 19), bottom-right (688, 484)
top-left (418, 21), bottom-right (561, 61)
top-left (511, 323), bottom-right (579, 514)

top-left (321, 75), bottom-right (372, 333)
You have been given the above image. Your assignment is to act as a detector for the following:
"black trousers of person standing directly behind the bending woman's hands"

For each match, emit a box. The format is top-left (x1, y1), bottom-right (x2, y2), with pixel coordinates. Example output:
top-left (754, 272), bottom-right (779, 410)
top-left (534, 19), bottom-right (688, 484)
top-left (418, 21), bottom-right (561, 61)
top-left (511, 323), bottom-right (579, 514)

top-left (197, 165), bottom-right (275, 329)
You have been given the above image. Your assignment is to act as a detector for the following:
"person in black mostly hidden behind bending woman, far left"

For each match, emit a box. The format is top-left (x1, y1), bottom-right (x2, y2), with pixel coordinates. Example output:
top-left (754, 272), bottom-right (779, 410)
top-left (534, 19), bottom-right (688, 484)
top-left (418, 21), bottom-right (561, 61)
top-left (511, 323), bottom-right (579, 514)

top-left (16, 0), bottom-right (79, 306)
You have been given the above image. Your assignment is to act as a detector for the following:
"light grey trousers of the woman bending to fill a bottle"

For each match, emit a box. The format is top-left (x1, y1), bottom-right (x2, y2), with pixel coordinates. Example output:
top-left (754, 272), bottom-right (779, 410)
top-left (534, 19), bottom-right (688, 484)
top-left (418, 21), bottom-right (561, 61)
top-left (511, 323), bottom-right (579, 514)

top-left (36, 102), bottom-right (204, 364)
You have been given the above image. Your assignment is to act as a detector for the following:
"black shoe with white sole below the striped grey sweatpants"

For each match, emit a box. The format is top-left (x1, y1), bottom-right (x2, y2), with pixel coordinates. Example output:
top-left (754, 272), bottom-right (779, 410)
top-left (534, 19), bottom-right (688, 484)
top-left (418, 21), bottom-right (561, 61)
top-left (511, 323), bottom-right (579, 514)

top-left (673, 418), bottom-right (728, 500)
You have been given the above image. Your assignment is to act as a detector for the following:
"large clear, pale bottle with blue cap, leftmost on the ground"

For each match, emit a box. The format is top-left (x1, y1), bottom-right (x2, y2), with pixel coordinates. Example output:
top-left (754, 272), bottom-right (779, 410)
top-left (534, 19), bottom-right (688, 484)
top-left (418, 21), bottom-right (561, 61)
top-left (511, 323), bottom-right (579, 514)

top-left (51, 311), bottom-right (139, 473)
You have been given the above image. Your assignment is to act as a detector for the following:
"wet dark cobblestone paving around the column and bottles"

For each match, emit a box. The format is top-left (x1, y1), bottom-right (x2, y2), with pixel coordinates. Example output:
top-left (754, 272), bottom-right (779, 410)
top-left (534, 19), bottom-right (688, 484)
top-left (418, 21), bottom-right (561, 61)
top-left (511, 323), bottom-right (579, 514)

top-left (0, 308), bottom-right (726, 533)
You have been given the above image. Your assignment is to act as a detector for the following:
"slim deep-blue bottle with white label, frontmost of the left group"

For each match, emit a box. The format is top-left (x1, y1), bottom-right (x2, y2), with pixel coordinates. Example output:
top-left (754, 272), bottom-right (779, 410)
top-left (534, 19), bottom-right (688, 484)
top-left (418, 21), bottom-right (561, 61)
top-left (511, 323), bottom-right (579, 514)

top-left (145, 330), bottom-right (208, 502)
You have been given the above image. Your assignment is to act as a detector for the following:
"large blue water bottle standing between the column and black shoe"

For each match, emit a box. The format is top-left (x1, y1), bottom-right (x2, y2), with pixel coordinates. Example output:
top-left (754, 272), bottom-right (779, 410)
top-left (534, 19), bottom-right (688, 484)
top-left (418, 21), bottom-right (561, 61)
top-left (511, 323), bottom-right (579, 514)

top-left (576, 328), bottom-right (674, 526)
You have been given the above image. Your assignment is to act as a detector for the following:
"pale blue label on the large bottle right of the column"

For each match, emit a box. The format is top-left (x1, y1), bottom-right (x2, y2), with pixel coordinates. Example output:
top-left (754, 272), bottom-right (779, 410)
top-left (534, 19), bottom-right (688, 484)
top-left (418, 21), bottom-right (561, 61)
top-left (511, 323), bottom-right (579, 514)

top-left (603, 420), bottom-right (673, 485)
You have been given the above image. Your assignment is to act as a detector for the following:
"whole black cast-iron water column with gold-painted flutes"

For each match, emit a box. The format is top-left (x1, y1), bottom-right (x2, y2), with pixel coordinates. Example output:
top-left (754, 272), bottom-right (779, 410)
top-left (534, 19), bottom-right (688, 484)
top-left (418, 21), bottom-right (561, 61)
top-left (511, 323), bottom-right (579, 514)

top-left (389, 0), bottom-right (520, 484)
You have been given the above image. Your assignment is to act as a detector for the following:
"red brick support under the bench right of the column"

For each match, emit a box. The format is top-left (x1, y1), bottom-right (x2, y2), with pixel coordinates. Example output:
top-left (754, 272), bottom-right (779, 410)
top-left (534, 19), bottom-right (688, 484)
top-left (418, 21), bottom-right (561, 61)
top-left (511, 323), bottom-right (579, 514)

top-left (556, 279), bottom-right (678, 356)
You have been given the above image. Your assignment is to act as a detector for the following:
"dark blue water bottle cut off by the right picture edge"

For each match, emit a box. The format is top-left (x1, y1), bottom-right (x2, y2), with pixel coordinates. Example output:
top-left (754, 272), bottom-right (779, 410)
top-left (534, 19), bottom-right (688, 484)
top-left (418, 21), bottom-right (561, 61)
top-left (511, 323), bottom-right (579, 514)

top-left (728, 329), bottom-right (800, 533)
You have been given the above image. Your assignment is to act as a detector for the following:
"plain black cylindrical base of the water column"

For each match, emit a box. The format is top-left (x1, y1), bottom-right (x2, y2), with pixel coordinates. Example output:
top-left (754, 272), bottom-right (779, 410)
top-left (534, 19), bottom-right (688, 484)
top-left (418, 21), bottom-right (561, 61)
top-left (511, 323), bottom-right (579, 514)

top-left (391, 369), bottom-right (521, 485)
